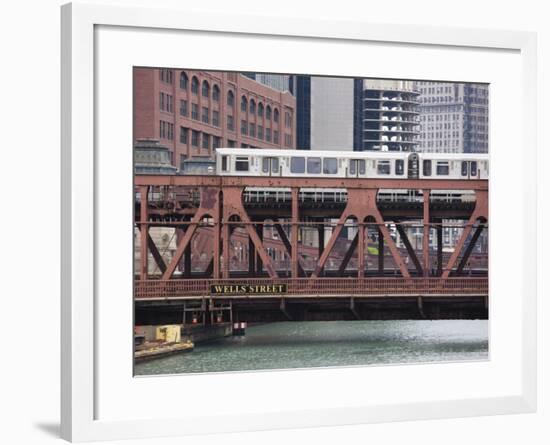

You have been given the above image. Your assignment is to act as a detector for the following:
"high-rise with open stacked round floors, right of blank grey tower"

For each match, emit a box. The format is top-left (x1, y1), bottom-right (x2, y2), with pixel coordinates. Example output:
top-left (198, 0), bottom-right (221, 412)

top-left (362, 79), bottom-right (419, 151)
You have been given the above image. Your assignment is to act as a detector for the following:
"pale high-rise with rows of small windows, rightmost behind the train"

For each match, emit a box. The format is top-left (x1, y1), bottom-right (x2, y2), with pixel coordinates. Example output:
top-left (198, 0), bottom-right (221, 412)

top-left (416, 82), bottom-right (489, 153)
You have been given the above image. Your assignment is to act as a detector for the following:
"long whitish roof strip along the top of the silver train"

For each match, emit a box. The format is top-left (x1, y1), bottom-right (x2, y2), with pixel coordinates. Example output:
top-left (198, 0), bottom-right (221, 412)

top-left (216, 148), bottom-right (489, 160)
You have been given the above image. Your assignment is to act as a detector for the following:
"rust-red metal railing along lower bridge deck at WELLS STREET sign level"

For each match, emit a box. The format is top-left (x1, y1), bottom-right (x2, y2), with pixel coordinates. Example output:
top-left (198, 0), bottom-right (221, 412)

top-left (135, 277), bottom-right (489, 300)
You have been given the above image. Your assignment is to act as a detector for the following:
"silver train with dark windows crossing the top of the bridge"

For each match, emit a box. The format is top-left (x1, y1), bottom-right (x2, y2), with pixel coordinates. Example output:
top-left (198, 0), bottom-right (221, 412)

top-left (216, 148), bottom-right (489, 180)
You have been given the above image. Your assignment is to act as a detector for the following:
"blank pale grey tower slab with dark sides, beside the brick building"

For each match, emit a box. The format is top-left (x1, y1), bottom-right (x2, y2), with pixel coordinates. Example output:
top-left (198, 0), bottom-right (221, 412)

top-left (290, 75), bottom-right (362, 150)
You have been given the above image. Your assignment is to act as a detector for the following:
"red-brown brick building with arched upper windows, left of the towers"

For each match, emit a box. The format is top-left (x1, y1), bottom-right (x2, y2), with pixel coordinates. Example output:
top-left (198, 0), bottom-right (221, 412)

top-left (134, 68), bottom-right (296, 168)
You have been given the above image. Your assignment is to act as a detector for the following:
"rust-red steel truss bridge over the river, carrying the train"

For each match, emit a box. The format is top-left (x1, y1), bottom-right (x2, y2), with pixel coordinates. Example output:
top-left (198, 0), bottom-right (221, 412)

top-left (134, 175), bottom-right (489, 321)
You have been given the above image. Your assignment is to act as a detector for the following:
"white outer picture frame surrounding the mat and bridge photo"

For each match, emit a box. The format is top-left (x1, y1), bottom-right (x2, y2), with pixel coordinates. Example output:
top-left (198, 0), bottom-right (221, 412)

top-left (61, 3), bottom-right (537, 441)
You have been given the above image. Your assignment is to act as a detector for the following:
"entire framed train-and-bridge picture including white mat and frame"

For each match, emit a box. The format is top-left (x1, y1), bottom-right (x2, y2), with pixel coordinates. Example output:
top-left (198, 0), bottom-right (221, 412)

top-left (62, 3), bottom-right (537, 441)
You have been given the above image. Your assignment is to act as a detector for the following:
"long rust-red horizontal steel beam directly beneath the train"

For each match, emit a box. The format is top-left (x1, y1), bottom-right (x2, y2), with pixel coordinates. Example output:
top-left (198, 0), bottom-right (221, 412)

top-left (134, 175), bottom-right (489, 191)
